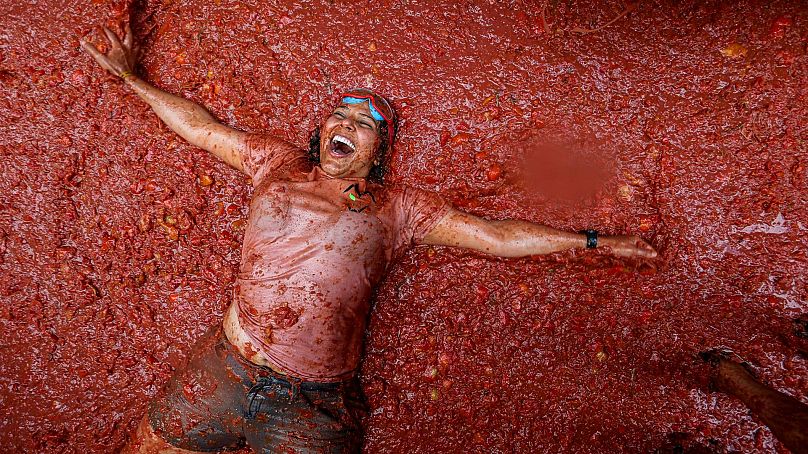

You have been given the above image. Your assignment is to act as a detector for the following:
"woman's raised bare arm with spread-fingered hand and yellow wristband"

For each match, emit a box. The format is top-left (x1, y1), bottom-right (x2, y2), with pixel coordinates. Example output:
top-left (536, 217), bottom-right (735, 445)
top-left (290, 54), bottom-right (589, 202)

top-left (81, 25), bottom-right (247, 171)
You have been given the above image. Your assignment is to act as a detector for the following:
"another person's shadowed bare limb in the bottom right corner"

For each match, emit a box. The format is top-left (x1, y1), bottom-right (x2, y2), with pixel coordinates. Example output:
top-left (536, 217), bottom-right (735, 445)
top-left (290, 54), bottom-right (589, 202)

top-left (702, 352), bottom-right (808, 454)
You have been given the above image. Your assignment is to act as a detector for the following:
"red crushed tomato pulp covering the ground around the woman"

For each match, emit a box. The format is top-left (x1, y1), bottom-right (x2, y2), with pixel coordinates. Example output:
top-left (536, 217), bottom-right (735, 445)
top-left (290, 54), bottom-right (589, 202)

top-left (0, 0), bottom-right (808, 453)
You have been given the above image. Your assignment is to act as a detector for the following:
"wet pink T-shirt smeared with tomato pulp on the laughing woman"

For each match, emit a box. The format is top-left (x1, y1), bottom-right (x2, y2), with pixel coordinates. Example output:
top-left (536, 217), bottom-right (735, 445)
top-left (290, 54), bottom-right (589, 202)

top-left (235, 134), bottom-right (450, 382)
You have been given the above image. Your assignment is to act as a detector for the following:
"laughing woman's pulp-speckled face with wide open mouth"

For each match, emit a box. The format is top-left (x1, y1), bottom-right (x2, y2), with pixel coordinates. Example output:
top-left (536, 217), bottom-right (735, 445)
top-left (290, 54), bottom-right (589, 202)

top-left (320, 102), bottom-right (381, 178)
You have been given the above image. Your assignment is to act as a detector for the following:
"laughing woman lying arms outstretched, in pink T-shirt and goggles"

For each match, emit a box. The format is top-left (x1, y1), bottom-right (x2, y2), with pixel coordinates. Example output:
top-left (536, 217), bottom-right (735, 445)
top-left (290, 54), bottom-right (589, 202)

top-left (82, 23), bottom-right (657, 452)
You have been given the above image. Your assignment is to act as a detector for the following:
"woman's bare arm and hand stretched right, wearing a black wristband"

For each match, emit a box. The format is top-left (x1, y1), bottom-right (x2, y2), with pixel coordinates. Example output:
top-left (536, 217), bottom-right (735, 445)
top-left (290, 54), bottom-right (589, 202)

top-left (422, 209), bottom-right (657, 258)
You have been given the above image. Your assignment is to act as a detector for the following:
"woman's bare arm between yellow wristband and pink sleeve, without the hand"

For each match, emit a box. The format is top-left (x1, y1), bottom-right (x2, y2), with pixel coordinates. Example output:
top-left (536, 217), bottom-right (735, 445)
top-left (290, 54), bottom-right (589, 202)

top-left (126, 76), bottom-right (246, 170)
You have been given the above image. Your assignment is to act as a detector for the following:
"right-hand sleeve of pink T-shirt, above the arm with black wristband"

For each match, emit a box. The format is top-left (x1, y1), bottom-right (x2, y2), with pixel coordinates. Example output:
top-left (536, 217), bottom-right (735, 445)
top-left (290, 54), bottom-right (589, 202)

top-left (394, 186), bottom-right (452, 247)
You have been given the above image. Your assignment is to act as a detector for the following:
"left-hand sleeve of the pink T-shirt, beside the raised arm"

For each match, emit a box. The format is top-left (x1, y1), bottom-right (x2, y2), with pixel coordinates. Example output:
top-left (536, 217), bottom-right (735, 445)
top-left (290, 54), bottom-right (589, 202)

top-left (241, 133), bottom-right (307, 186)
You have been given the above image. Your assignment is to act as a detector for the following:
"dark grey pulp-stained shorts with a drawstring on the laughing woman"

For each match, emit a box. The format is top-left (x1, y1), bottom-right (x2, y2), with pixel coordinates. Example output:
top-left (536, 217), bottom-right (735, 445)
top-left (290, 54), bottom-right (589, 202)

top-left (149, 328), bottom-right (367, 453)
